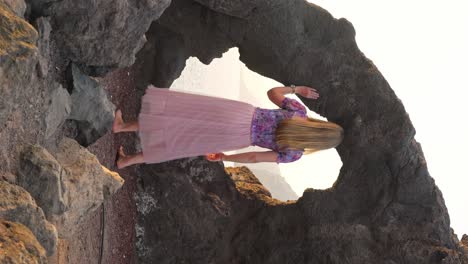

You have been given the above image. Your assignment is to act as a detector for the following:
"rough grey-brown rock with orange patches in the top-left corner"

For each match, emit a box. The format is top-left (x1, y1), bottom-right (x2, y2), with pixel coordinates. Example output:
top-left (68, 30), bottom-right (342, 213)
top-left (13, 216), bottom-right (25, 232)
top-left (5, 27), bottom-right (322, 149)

top-left (0, 1), bottom-right (57, 174)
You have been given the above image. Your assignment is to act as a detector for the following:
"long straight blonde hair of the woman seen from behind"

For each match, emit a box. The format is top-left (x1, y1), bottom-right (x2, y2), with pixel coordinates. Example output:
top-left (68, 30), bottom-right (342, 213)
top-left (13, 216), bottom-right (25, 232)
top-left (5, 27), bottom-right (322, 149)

top-left (275, 117), bottom-right (343, 154)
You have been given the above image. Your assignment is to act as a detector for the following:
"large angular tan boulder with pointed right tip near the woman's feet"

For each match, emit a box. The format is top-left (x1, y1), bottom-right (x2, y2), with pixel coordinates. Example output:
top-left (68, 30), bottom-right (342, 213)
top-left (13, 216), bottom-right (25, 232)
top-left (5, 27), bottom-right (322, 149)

top-left (18, 138), bottom-right (123, 238)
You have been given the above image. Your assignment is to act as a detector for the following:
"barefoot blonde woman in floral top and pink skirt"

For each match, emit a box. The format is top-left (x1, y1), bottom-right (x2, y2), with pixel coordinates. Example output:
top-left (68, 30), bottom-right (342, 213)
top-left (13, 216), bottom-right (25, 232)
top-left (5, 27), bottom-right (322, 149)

top-left (112, 85), bottom-right (343, 168)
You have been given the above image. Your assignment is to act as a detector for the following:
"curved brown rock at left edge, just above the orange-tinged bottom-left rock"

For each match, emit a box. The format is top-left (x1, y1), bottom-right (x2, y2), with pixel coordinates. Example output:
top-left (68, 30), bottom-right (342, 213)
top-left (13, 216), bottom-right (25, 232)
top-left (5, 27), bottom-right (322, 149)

top-left (0, 181), bottom-right (57, 256)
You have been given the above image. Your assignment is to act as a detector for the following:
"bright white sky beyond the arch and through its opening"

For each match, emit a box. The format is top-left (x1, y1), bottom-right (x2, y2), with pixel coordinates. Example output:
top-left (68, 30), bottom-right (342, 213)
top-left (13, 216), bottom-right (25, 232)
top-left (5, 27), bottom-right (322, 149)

top-left (171, 0), bottom-right (468, 237)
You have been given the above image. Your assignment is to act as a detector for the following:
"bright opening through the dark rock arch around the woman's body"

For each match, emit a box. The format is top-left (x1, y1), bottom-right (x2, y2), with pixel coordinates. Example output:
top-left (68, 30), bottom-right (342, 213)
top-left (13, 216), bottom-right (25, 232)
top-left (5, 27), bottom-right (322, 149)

top-left (170, 48), bottom-right (342, 201)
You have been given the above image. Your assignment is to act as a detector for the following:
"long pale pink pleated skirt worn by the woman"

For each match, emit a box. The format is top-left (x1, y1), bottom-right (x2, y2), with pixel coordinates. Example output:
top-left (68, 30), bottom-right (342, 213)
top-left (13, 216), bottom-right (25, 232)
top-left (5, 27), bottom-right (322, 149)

top-left (138, 85), bottom-right (255, 163)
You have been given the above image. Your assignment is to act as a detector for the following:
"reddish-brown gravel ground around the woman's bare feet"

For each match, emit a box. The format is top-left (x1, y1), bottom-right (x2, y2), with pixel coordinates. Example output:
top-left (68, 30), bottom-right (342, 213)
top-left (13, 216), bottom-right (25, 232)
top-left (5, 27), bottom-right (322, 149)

top-left (49, 68), bottom-right (143, 264)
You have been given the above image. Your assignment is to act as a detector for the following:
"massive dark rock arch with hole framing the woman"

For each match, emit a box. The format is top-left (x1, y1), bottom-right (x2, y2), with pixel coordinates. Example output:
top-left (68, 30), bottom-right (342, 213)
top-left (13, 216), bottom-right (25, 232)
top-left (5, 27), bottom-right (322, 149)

top-left (132, 0), bottom-right (467, 264)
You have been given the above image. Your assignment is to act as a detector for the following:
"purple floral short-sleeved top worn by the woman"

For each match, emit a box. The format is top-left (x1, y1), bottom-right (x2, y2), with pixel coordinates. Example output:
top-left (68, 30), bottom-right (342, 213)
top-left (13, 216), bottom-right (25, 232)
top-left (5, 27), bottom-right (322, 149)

top-left (250, 97), bottom-right (307, 163)
